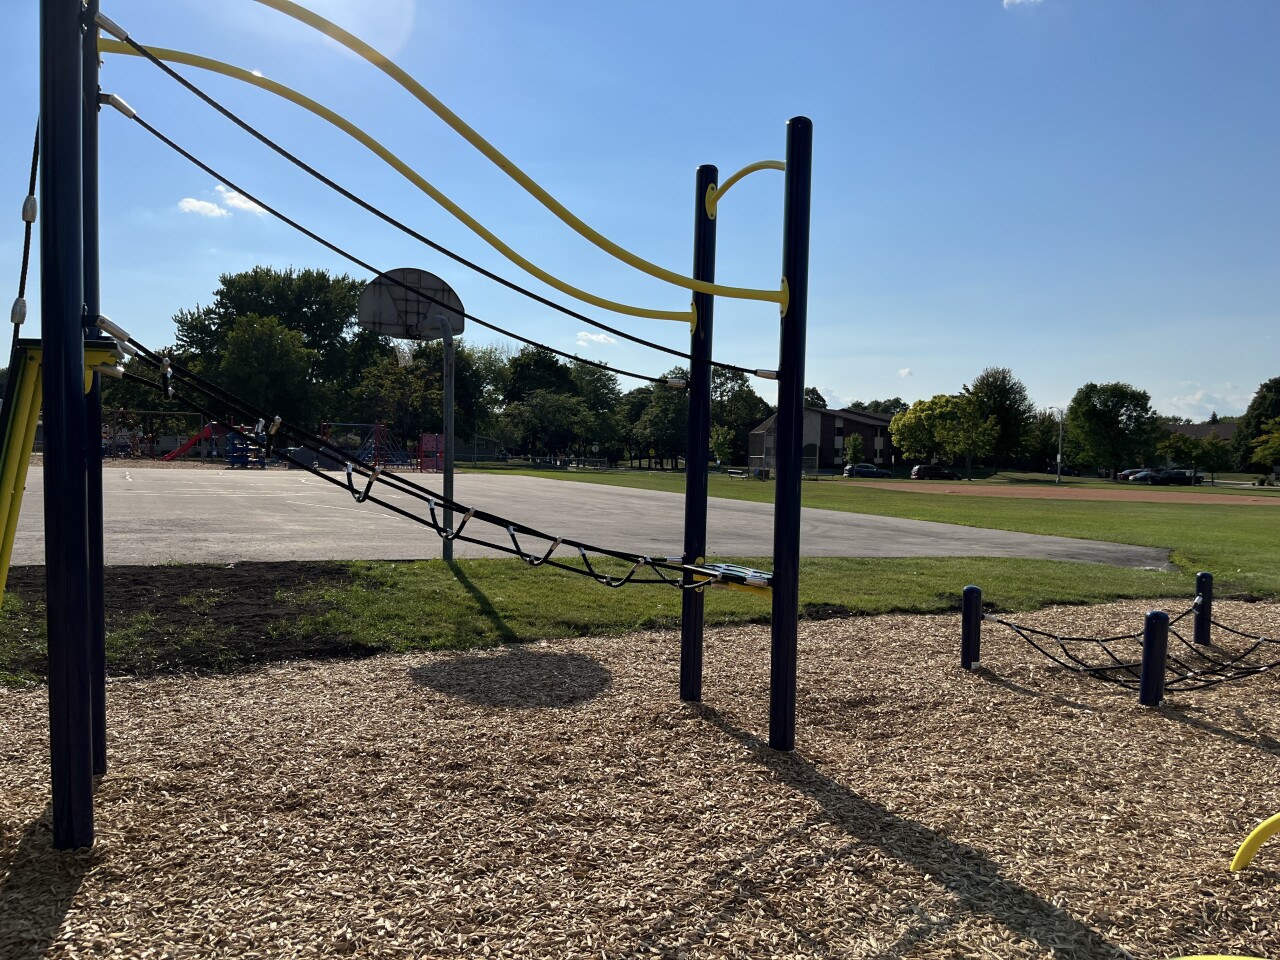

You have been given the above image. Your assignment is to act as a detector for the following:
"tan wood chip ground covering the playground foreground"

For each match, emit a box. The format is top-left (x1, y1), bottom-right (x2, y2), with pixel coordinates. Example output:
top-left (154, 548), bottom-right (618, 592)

top-left (0, 602), bottom-right (1280, 960)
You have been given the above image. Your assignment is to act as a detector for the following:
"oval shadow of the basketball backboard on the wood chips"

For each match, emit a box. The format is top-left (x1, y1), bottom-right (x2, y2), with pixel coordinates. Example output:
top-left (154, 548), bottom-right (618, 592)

top-left (410, 646), bottom-right (613, 710)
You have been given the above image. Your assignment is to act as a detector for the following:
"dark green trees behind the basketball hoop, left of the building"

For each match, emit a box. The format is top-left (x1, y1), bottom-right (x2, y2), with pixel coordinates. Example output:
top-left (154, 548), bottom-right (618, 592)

top-left (94, 266), bottom-right (773, 465)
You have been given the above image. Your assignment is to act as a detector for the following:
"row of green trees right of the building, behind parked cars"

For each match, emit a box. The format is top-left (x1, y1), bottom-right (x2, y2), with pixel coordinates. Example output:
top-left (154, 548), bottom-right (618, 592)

top-left (890, 367), bottom-right (1280, 474)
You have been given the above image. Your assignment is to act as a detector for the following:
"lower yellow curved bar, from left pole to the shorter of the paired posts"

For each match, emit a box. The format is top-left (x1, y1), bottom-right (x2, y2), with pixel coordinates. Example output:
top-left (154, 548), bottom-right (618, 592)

top-left (97, 38), bottom-right (692, 323)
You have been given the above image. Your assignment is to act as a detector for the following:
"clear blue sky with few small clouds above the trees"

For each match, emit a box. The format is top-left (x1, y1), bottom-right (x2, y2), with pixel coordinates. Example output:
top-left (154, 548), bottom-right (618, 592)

top-left (0, 0), bottom-right (1280, 419)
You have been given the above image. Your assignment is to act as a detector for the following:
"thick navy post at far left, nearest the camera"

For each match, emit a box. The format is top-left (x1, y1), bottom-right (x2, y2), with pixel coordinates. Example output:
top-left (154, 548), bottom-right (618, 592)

top-left (40, 0), bottom-right (93, 850)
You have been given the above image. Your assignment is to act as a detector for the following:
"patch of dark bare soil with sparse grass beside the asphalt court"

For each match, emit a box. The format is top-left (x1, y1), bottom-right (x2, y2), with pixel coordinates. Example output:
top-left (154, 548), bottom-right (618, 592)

top-left (8, 561), bottom-right (378, 678)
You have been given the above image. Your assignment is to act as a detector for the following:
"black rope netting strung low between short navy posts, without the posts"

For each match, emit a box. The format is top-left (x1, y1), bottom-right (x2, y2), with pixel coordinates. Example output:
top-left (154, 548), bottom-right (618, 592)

top-left (982, 596), bottom-right (1280, 691)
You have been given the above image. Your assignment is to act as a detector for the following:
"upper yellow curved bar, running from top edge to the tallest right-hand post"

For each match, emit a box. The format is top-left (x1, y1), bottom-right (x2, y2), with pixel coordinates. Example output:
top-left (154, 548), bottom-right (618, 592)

top-left (245, 0), bottom-right (782, 303)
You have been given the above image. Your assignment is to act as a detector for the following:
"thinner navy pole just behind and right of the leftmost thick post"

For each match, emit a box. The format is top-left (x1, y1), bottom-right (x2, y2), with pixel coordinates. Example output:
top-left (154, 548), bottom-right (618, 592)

top-left (82, 0), bottom-right (106, 777)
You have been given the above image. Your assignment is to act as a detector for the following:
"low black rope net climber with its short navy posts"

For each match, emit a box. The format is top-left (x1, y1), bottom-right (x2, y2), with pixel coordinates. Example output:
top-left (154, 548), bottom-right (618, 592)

top-left (960, 572), bottom-right (1280, 706)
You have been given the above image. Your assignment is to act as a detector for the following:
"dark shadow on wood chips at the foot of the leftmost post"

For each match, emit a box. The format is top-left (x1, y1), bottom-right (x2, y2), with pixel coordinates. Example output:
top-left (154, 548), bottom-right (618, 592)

top-left (0, 808), bottom-right (93, 960)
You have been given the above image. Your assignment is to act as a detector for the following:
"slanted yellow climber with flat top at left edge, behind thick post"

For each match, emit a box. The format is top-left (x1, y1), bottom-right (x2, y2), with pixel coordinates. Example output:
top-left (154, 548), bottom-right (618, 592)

top-left (0, 339), bottom-right (115, 602)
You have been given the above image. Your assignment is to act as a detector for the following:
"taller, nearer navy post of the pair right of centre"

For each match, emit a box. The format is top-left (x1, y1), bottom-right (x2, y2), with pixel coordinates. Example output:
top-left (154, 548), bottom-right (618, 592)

top-left (769, 116), bottom-right (813, 750)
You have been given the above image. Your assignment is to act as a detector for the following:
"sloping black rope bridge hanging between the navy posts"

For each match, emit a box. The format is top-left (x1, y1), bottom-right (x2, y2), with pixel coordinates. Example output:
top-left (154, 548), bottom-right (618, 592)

top-left (97, 317), bottom-right (771, 593)
